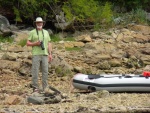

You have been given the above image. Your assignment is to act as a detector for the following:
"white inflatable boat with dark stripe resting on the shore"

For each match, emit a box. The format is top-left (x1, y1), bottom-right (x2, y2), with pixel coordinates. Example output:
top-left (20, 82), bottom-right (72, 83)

top-left (72, 72), bottom-right (150, 92)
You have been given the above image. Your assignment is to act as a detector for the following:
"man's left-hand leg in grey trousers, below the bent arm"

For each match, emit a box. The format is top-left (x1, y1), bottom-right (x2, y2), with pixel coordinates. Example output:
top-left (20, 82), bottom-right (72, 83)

top-left (32, 56), bottom-right (40, 89)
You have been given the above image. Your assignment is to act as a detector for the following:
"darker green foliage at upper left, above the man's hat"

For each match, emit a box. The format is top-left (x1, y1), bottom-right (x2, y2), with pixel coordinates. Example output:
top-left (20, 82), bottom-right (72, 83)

top-left (0, 0), bottom-right (58, 22)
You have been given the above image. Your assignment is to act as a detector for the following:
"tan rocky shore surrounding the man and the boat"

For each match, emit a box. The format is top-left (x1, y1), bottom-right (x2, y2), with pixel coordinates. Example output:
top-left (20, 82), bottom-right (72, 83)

top-left (0, 24), bottom-right (150, 113)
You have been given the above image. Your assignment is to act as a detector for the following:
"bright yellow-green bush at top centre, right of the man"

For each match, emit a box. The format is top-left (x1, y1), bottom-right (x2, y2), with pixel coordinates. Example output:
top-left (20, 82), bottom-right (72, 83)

top-left (62, 0), bottom-right (113, 29)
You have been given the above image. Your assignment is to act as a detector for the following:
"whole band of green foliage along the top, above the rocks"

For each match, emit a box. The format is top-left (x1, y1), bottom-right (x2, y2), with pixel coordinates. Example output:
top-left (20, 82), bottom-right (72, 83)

top-left (0, 0), bottom-right (150, 29)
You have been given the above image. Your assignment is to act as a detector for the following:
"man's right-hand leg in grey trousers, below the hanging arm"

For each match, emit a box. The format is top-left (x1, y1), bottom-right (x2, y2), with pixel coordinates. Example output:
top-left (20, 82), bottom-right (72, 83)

top-left (42, 56), bottom-right (48, 91)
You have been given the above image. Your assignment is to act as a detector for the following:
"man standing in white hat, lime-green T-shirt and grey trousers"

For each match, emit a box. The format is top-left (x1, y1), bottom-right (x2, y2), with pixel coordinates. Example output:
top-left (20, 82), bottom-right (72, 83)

top-left (26, 17), bottom-right (52, 91)
